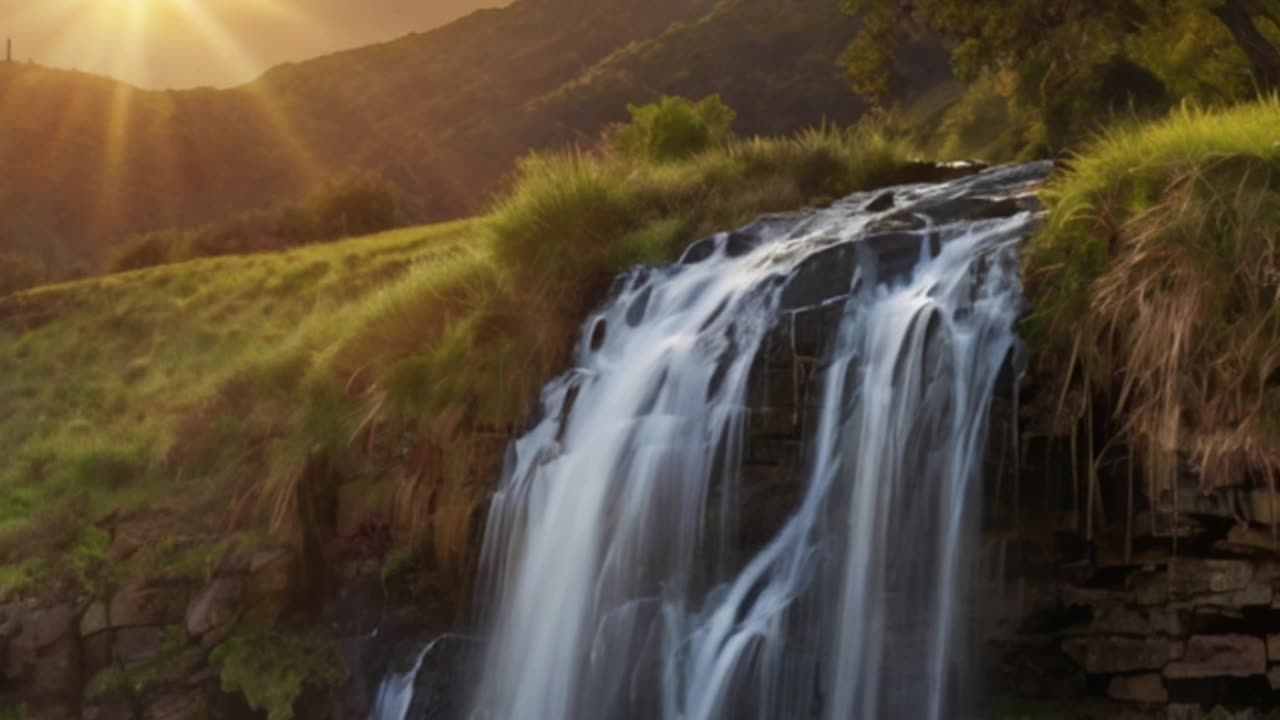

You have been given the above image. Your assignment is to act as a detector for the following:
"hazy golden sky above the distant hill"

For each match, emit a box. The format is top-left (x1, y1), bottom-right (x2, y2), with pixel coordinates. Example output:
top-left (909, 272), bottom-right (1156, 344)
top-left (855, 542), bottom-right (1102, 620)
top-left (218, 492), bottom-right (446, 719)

top-left (0, 0), bottom-right (509, 87)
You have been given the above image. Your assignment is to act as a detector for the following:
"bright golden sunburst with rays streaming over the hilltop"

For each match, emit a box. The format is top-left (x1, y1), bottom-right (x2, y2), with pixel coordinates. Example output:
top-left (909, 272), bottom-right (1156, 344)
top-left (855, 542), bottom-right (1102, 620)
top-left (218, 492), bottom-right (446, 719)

top-left (0, 0), bottom-right (320, 236)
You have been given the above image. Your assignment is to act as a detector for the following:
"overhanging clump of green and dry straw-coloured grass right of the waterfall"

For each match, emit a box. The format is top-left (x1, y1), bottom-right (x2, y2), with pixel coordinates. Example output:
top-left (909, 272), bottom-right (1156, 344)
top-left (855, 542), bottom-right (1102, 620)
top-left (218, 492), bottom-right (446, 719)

top-left (1025, 97), bottom-right (1280, 488)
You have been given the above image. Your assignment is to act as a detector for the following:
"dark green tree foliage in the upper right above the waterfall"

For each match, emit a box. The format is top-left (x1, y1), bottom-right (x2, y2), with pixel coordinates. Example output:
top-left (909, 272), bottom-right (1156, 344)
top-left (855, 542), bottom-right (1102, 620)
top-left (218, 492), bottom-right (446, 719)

top-left (841, 0), bottom-right (1280, 154)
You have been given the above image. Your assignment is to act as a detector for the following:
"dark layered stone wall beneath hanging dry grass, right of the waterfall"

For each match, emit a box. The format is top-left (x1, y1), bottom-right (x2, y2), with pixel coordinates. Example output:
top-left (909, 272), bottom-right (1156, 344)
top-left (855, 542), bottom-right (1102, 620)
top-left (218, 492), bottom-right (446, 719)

top-left (983, 425), bottom-right (1280, 719)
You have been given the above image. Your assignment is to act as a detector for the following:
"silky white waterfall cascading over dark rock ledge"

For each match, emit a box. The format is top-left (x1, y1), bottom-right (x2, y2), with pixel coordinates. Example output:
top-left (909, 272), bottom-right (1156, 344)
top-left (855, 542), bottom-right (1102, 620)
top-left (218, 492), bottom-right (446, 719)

top-left (472, 164), bottom-right (1048, 720)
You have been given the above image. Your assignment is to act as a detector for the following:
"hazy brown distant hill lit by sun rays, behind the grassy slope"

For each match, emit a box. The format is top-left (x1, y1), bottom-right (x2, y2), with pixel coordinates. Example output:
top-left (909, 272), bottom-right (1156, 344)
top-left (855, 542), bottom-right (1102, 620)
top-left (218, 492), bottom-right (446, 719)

top-left (0, 0), bottom-right (945, 270)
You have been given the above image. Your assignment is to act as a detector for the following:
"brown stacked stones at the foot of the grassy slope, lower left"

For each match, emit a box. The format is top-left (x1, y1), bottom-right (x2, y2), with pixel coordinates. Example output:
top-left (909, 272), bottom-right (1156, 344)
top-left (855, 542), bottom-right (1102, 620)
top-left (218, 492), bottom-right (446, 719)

top-left (0, 550), bottom-right (300, 720)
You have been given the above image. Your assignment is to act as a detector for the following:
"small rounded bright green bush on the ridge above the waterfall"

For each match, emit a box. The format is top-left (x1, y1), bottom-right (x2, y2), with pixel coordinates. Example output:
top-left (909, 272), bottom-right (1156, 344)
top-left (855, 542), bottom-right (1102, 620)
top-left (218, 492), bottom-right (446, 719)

top-left (613, 95), bottom-right (737, 161)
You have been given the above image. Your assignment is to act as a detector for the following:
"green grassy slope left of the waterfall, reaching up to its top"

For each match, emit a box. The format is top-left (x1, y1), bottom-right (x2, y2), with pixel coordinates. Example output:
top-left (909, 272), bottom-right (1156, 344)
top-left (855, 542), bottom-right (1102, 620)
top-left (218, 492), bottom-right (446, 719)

top-left (0, 121), bottom-right (908, 594)
